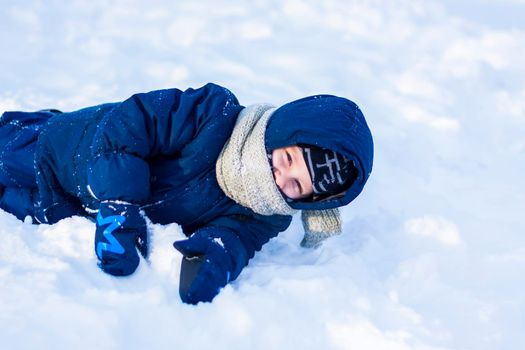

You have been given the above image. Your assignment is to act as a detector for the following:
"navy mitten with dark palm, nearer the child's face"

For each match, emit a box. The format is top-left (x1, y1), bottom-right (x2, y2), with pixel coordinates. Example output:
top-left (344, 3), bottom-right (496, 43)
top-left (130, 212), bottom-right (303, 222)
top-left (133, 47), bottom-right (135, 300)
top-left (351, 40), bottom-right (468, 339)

top-left (173, 232), bottom-right (234, 304)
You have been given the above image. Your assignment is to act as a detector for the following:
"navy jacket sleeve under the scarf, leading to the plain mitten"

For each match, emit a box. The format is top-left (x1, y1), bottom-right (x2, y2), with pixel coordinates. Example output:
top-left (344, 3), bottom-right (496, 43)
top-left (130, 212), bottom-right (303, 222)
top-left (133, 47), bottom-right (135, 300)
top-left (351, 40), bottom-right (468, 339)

top-left (190, 215), bottom-right (292, 281)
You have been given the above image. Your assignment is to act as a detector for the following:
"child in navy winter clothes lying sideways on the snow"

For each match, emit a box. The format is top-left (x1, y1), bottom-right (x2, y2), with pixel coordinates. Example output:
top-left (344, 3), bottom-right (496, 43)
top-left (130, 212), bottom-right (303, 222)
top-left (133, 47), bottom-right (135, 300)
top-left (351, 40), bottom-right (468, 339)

top-left (0, 83), bottom-right (373, 304)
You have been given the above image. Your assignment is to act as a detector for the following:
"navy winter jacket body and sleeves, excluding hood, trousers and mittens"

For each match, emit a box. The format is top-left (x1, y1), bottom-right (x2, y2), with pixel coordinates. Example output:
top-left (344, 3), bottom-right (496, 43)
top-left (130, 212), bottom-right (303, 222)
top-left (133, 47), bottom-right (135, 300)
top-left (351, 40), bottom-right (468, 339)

top-left (29, 84), bottom-right (291, 276)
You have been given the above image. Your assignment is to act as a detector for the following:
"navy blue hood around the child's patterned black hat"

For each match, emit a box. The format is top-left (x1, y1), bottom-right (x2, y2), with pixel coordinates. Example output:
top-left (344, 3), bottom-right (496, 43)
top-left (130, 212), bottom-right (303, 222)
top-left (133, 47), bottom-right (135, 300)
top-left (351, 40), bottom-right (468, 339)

top-left (265, 95), bottom-right (374, 210)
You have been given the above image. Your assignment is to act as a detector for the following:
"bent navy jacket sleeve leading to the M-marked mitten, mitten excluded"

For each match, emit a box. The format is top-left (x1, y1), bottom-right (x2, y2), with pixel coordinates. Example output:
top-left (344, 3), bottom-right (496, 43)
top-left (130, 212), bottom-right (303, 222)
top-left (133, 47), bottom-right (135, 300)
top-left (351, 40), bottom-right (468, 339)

top-left (88, 83), bottom-right (242, 203)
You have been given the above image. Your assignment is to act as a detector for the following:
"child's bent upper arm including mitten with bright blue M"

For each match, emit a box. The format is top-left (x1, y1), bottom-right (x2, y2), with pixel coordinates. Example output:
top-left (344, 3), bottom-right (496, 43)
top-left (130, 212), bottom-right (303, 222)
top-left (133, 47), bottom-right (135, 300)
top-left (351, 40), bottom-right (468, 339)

top-left (88, 84), bottom-right (242, 276)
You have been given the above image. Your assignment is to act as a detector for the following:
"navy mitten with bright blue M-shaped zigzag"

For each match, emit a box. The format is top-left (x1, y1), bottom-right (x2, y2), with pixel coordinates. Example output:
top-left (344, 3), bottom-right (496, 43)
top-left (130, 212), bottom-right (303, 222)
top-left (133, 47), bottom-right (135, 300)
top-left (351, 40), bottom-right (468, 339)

top-left (95, 202), bottom-right (148, 276)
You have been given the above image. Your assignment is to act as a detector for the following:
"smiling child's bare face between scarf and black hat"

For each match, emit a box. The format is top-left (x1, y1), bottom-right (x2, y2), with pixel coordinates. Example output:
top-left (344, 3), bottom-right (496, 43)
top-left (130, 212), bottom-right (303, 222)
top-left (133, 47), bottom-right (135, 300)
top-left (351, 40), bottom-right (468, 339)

top-left (272, 146), bottom-right (313, 199)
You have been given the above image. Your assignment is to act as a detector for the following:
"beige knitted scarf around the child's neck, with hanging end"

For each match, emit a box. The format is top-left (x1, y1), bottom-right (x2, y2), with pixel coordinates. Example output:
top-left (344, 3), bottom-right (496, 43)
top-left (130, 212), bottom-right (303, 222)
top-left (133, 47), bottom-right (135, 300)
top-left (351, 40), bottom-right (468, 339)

top-left (216, 104), bottom-right (341, 247)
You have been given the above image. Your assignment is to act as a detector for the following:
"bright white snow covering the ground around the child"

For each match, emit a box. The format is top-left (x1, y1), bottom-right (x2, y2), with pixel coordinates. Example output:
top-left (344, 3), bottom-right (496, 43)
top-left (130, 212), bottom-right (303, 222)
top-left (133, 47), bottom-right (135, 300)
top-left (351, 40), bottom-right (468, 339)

top-left (0, 0), bottom-right (525, 350)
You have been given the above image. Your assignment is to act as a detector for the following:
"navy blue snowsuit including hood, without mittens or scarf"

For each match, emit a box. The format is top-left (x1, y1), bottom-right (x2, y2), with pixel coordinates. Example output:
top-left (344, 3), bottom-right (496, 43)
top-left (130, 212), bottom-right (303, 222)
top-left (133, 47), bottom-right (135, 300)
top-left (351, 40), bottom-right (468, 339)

top-left (0, 83), bottom-right (373, 304)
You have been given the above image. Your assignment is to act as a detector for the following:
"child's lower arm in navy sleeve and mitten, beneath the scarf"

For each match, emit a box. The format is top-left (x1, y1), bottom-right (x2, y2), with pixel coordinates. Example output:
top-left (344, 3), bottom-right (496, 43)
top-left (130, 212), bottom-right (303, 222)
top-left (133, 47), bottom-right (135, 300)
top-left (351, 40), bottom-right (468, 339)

top-left (174, 215), bottom-right (291, 304)
